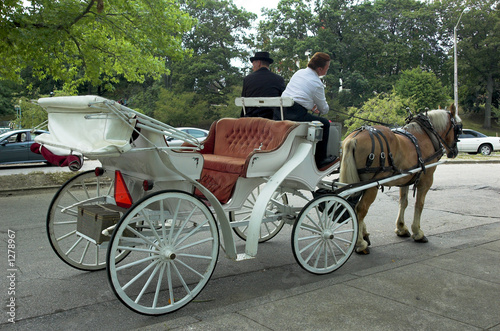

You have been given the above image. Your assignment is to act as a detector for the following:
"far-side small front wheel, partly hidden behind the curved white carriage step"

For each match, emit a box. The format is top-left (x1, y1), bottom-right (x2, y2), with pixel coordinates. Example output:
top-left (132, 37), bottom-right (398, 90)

top-left (229, 186), bottom-right (288, 243)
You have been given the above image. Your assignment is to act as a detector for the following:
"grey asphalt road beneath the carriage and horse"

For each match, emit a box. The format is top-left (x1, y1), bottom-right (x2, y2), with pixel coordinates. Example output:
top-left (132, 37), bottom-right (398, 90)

top-left (0, 164), bottom-right (500, 330)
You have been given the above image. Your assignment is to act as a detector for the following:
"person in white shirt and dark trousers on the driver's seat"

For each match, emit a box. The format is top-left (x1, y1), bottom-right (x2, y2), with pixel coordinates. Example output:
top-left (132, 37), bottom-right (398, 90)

top-left (280, 52), bottom-right (335, 169)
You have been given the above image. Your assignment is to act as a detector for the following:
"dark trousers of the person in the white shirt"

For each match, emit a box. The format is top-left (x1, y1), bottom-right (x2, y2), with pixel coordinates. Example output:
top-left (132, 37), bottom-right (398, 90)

top-left (274, 103), bottom-right (330, 162)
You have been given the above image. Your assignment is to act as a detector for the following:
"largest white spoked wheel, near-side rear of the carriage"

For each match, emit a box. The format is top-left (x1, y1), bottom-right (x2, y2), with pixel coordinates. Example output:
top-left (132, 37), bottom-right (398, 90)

top-left (107, 191), bottom-right (219, 315)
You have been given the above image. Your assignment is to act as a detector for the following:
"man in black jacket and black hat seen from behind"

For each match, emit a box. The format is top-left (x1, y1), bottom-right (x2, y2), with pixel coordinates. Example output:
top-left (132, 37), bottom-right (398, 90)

top-left (241, 52), bottom-right (286, 119)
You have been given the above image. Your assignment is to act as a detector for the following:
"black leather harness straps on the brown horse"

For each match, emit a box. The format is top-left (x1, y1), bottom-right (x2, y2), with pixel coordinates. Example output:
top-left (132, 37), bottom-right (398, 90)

top-left (354, 113), bottom-right (460, 186)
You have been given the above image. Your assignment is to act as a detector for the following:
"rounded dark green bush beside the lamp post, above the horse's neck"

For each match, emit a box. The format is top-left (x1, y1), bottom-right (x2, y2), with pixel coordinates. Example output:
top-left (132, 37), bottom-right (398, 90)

top-left (394, 68), bottom-right (448, 112)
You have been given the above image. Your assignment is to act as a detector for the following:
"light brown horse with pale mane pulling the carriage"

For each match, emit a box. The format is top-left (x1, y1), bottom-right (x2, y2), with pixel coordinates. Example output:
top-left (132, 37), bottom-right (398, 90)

top-left (339, 106), bottom-right (462, 254)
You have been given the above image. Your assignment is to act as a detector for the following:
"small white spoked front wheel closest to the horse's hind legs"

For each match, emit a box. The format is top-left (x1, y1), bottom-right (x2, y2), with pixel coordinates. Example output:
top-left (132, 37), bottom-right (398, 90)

top-left (292, 194), bottom-right (358, 274)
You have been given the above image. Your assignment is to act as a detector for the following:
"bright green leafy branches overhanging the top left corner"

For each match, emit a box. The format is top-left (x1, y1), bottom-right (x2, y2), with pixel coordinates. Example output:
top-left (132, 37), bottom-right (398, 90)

top-left (0, 0), bottom-right (193, 92)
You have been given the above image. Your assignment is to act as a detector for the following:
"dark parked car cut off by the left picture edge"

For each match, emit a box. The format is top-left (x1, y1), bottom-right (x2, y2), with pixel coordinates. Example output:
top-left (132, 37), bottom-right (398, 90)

top-left (0, 129), bottom-right (48, 164)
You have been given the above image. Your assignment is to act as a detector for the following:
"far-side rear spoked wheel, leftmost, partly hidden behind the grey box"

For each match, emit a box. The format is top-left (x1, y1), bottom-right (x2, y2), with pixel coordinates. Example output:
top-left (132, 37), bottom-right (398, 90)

top-left (47, 170), bottom-right (126, 271)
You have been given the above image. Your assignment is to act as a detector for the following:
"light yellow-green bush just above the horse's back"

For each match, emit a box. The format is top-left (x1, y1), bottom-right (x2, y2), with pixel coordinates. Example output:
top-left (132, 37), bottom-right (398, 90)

top-left (344, 92), bottom-right (415, 133)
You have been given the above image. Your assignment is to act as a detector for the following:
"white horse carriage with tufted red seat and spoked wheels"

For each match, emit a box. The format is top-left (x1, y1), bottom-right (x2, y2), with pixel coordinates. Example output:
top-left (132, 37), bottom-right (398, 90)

top-left (36, 96), bottom-right (460, 315)
